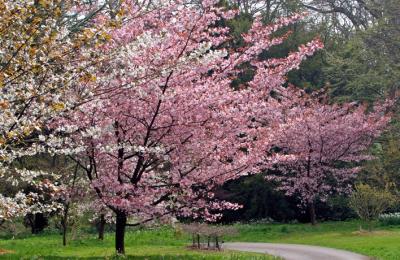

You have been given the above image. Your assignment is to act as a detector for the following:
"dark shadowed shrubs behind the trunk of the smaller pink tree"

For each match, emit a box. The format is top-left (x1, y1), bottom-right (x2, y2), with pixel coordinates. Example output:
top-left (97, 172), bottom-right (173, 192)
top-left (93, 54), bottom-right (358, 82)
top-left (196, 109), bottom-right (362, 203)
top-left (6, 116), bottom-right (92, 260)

top-left (217, 175), bottom-right (355, 223)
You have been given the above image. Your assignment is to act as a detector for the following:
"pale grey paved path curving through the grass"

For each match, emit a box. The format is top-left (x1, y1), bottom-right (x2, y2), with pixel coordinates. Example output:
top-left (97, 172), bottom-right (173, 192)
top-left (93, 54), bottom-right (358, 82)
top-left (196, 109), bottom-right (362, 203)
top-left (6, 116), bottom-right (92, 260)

top-left (223, 242), bottom-right (369, 260)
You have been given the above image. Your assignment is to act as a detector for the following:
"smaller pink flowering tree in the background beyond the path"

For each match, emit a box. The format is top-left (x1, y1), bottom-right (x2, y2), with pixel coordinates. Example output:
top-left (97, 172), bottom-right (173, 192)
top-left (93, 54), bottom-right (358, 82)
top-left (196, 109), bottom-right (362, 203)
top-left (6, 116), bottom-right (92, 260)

top-left (267, 88), bottom-right (390, 225)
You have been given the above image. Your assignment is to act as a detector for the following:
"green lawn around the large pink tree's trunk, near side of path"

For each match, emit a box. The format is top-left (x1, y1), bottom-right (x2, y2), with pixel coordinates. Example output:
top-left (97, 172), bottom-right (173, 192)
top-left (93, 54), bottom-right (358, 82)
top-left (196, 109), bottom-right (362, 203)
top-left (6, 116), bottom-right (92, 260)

top-left (0, 228), bottom-right (275, 260)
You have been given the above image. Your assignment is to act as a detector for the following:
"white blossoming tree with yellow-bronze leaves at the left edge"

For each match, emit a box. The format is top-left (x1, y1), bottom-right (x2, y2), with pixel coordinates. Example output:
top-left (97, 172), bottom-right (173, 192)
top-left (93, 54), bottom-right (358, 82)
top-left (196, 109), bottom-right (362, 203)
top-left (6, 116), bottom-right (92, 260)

top-left (0, 0), bottom-right (118, 228)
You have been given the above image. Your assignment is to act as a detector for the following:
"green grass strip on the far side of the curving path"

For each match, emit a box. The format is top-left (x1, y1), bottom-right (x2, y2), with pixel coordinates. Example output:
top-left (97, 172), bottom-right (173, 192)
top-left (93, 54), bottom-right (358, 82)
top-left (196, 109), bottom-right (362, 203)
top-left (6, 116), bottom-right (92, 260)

top-left (228, 221), bottom-right (400, 260)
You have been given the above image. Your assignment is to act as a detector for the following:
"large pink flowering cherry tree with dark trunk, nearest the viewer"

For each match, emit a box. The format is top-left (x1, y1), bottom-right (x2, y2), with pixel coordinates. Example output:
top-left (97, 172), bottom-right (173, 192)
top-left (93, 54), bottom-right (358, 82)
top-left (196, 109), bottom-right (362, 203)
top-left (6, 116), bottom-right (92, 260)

top-left (52, 1), bottom-right (322, 253)
